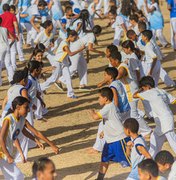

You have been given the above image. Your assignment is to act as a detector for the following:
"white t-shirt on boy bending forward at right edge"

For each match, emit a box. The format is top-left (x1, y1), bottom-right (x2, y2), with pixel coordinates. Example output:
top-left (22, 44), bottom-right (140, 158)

top-left (139, 88), bottom-right (175, 136)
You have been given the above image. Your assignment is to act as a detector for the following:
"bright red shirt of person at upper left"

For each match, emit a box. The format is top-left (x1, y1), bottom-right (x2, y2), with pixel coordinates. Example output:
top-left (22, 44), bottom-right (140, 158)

top-left (0, 11), bottom-right (17, 37)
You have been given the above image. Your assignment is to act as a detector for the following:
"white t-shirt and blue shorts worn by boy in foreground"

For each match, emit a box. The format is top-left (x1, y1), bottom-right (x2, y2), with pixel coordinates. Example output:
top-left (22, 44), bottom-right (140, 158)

top-left (98, 102), bottom-right (130, 167)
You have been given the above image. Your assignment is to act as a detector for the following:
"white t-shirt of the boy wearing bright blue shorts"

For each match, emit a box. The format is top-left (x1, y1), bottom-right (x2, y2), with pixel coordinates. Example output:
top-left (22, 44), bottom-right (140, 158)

top-left (98, 102), bottom-right (126, 143)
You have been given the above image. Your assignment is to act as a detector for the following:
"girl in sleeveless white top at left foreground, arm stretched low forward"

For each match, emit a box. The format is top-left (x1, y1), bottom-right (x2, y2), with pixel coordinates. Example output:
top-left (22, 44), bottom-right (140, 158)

top-left (0, 96), bottom-right (59, 180)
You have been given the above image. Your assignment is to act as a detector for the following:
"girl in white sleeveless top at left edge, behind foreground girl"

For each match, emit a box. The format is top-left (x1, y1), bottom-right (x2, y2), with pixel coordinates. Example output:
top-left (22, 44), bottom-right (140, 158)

top-left (2, 68), bottom-right (28, 119)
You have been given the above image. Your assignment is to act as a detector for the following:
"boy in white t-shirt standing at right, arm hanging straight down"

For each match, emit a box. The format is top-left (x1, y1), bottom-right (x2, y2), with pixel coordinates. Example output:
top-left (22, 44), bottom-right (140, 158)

top-left (142, 30), bottom-right (161, 86)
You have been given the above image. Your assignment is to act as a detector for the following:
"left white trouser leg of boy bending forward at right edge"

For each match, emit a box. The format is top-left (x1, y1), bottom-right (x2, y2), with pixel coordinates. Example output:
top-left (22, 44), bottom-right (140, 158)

top-left (149, 132), bottom-right (166, 158)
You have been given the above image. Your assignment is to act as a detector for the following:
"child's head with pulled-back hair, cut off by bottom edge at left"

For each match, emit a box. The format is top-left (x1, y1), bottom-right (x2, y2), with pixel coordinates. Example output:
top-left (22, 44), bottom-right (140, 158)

top-left (32, 157), bottom-right (56, 180)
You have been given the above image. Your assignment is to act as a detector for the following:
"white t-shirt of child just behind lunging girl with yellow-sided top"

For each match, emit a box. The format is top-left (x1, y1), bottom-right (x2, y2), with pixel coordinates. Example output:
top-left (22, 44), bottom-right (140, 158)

top-left (34, 30), bottom-right (54, 48)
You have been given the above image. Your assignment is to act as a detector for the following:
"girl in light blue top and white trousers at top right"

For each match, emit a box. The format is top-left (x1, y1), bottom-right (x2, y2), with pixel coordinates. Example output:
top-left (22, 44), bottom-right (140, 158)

top-left (145, 0), bottom-right (169, 47)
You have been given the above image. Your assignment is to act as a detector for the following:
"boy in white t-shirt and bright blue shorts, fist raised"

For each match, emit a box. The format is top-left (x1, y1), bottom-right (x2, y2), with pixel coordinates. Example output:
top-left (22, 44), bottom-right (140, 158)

top-left (90, 87), bottom-right (130, 180)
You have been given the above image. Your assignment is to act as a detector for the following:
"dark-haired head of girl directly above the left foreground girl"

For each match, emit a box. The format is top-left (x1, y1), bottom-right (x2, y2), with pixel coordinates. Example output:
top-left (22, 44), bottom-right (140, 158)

top-left (11, 68), bottom-right (28, 86)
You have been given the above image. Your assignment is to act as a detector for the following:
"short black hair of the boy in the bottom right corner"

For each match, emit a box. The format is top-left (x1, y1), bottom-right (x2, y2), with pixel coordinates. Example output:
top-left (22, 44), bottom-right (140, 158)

top-left (155, 150), bottom-right (174, 165)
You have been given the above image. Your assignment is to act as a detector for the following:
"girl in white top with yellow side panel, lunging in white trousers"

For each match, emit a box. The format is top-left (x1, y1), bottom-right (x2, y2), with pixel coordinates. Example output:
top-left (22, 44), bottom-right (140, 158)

top-left (41, 30), bottom-right (85, 99)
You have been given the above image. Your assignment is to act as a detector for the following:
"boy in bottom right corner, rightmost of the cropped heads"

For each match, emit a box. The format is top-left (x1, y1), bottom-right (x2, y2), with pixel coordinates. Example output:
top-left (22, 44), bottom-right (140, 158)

top-left (155, 151), bottom-right (176, 180)
